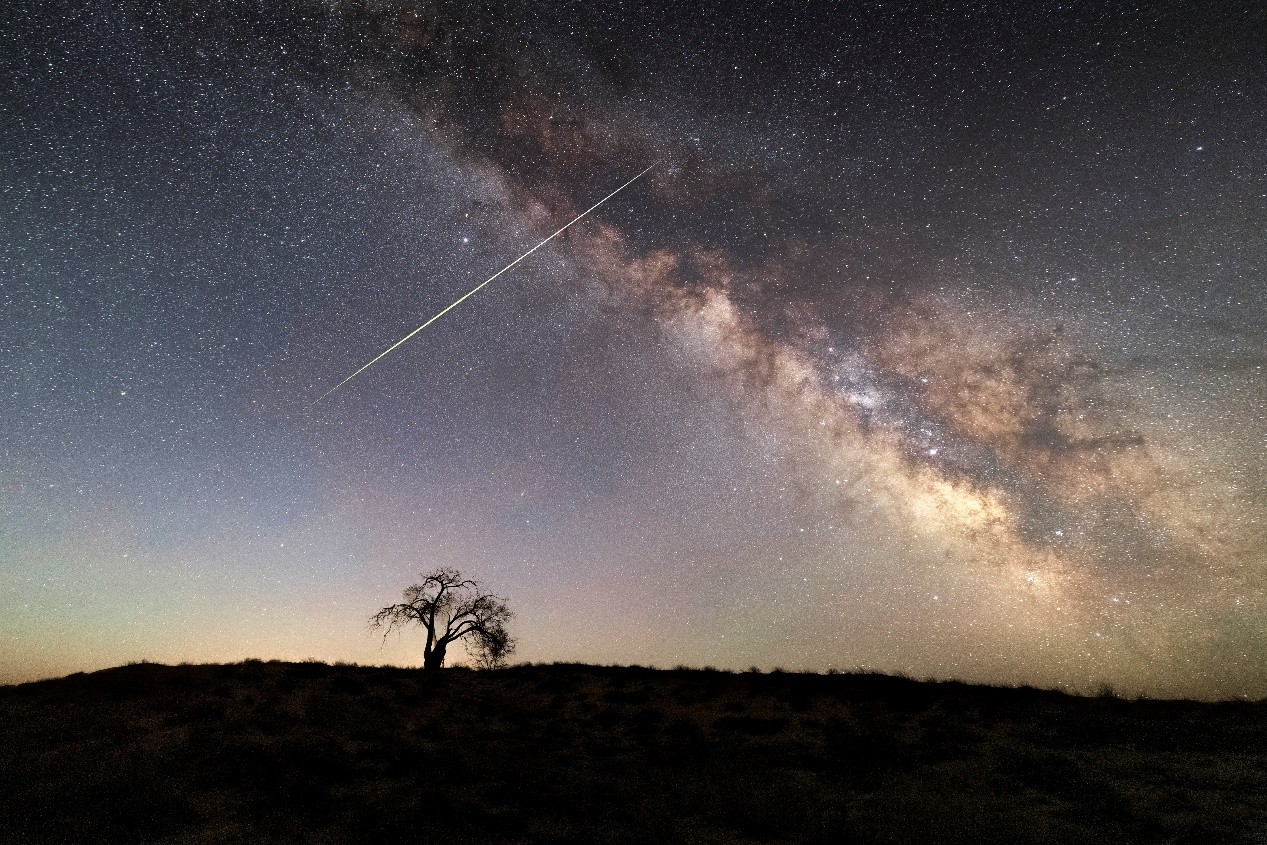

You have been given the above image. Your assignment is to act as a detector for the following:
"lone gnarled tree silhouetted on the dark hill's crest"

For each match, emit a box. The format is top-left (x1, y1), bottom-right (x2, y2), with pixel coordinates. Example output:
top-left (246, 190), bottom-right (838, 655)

top-left (370, 568), bottom-right (516, 669)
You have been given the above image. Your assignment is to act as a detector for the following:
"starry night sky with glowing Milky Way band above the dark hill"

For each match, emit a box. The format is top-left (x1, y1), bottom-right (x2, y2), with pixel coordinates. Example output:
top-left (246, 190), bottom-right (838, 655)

top-left (0, 0), bottom-right (1267, 697)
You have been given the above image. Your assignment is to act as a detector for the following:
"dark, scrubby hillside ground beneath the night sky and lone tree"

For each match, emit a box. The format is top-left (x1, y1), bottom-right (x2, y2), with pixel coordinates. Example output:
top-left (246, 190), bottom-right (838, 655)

top-left (0, 661), bottom-right (1267, 845)
